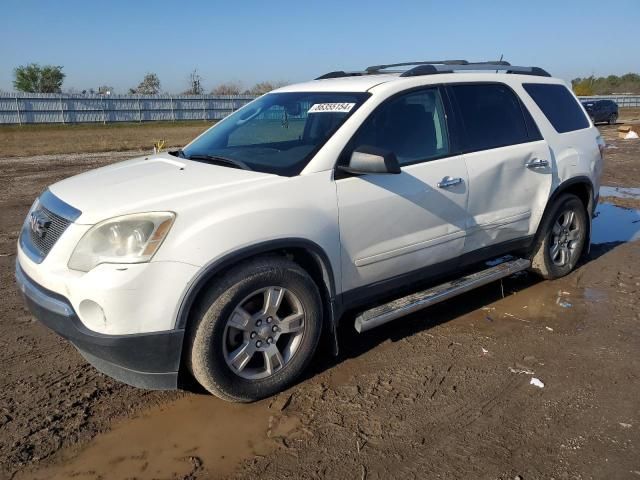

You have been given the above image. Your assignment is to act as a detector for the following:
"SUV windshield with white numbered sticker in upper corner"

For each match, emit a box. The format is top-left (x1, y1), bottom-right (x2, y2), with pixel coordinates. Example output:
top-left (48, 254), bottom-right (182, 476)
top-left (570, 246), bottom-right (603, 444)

top-left (182, 92), bottom-right (369, 176)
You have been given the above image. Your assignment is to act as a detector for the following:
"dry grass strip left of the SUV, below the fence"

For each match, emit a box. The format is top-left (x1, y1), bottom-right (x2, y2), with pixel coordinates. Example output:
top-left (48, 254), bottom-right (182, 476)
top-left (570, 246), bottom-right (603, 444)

top-left (0, 120), bottom-right (213, 157)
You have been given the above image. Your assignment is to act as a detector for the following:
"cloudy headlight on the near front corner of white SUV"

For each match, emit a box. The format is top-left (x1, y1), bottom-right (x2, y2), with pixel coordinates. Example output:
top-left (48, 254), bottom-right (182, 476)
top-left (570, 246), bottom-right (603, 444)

top-left (69, 212), bottom-right (176, 272)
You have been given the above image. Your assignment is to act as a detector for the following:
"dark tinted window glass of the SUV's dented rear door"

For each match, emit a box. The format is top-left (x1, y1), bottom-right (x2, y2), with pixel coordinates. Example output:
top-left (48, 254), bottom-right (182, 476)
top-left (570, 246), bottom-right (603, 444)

top-left (451, 83), bottom-right (540, 152)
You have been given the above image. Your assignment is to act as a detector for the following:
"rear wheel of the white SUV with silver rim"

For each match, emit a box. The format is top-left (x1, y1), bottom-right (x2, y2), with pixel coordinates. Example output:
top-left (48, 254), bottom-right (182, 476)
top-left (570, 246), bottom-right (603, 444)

top-left (531, 193), bottom-right (589, 280)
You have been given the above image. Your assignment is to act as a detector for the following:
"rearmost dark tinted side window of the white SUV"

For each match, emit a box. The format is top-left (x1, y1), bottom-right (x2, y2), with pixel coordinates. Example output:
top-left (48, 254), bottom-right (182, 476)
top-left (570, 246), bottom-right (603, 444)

top-left (522, 83), bottom-right (589, 133)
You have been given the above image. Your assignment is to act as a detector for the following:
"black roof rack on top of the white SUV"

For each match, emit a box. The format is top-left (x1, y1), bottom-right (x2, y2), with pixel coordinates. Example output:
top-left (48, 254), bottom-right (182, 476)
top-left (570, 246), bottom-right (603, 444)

top-left (316, 60), bottom-right (551, 80)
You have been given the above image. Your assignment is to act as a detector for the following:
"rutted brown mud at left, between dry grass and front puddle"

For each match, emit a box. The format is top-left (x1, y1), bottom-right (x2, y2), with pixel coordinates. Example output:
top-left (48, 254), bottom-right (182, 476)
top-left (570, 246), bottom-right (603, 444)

top-left (0, 152), bottom-right (182, 478)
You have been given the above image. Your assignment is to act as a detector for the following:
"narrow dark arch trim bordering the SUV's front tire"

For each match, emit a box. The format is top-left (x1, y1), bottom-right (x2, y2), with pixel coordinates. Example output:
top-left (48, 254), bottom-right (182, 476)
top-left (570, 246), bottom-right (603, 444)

top-left (170, 238), bottom-right (341, 355)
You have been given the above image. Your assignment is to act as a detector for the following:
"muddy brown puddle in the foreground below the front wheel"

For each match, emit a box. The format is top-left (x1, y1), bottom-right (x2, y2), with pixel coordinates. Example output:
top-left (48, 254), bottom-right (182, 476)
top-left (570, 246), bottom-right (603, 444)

top-left (15, 395), bottom-right (298, 480)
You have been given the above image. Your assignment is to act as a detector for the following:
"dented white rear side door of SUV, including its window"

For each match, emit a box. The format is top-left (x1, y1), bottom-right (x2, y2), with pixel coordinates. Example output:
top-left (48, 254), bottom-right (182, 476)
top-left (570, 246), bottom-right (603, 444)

top-left (448, 83), bottom-right (552, 253)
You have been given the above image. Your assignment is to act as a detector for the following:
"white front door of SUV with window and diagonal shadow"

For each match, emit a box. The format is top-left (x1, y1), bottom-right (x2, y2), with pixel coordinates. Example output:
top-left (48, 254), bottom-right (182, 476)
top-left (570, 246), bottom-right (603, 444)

top-left (336, 88), bottom-right (468, 296)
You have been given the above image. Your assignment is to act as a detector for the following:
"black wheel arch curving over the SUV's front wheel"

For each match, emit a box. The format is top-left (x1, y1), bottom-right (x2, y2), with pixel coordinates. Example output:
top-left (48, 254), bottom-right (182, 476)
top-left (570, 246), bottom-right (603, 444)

top-left (170, 238), bottom-right (338, 354)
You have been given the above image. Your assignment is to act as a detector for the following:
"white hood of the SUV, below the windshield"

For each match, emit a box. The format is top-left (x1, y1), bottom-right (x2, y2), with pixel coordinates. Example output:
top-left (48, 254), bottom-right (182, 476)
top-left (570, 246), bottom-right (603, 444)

top-left (49, 153), bottom-right (283, 224)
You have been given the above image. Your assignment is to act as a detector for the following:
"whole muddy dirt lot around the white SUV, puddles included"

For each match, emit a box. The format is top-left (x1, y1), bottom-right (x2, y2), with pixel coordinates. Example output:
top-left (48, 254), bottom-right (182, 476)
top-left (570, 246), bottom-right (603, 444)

top-left (0, 121), bottom-right (640, 480)
